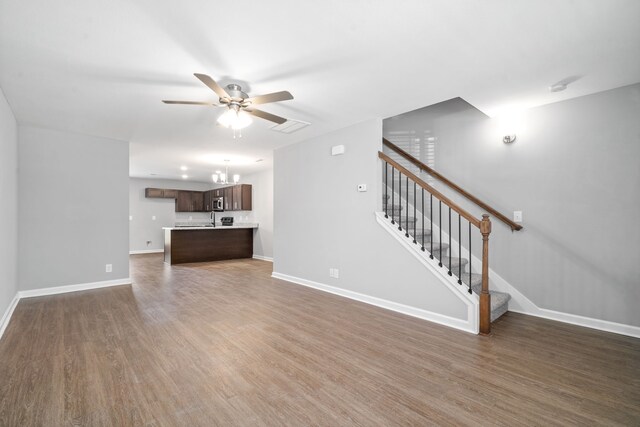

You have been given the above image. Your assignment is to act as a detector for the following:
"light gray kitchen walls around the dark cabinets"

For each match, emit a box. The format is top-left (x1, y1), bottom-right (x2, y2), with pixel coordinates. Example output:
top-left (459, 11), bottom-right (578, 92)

top-left (129, 169), bottom-right (273, 258)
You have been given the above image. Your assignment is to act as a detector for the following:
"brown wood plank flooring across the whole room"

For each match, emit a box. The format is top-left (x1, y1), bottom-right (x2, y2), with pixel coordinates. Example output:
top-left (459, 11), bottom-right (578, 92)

top-left (0, 254), bottom-right (640, 426)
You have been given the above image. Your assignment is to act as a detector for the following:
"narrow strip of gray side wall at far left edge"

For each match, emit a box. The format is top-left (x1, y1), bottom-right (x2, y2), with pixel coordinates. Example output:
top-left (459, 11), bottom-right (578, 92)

top-left (0, 89), bottom-right (18, 319)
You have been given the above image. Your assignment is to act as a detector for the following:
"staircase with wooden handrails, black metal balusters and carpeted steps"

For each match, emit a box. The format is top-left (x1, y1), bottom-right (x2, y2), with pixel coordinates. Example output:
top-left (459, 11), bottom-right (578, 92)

top-left (378, 139), bottom-right (522, 335)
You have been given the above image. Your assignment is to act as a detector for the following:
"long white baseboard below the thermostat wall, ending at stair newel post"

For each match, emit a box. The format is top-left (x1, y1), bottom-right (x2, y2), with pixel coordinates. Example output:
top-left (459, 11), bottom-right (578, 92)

top-left (271, 272), bottom-right (478, 334)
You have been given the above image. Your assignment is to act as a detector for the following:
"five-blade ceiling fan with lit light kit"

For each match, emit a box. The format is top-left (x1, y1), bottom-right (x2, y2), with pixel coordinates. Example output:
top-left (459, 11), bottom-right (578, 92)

top-left (162, 73), bottom-right (293, 131)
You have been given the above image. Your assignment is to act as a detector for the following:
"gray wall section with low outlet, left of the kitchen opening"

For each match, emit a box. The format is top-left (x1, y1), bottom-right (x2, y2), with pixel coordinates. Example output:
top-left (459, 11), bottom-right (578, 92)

top-left (18, 126), bottom-right (129, 290)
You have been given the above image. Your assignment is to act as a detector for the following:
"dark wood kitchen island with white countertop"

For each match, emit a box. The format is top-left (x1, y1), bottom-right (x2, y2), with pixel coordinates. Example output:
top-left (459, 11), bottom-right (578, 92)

top-left (163, 223), bottom-right (258, 264)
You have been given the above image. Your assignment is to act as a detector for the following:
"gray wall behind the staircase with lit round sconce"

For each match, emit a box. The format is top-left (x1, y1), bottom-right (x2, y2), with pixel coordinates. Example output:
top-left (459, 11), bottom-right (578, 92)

top-left (384, 84), bottom-right (640, 326)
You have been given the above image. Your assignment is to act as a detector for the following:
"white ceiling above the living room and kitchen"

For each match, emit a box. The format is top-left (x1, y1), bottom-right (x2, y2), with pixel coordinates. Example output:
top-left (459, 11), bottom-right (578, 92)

top-left (0, 0), bottom-right (640, 181)
